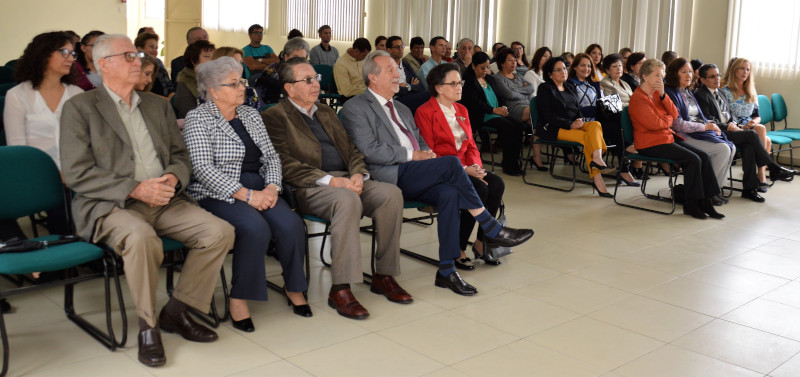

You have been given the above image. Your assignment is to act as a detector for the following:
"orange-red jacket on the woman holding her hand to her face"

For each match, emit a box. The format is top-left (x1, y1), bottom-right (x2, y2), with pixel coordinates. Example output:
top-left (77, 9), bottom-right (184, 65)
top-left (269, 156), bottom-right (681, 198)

top-left (628, 87), bottom-right (683, 149)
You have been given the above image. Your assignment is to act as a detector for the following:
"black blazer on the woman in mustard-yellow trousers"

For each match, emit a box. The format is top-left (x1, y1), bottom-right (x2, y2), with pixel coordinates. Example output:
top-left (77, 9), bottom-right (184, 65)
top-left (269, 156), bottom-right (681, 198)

top-left (535, 81), bottom-right (583, 140)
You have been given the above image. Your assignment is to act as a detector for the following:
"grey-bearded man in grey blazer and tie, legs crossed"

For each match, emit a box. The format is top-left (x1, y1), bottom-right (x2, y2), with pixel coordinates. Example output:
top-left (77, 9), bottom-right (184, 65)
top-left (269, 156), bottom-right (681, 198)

top-left (341, 50), bottom-right (533, 295)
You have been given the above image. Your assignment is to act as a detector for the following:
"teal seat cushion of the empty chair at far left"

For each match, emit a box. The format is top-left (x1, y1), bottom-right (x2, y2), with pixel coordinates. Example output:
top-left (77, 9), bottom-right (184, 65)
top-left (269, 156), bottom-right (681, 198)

top-left (0, 235), bottom-right (103, 275)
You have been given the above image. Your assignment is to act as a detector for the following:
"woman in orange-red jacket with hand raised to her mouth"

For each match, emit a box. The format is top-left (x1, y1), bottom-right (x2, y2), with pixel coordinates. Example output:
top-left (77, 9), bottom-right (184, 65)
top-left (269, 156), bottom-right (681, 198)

top-left (628, 59), bottom-right (725, 219)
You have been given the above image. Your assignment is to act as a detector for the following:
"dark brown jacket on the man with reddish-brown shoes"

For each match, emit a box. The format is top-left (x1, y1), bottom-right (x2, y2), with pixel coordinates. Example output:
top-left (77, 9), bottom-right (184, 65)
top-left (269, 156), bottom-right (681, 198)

top-left (261, 100), bottom-right (369, 187)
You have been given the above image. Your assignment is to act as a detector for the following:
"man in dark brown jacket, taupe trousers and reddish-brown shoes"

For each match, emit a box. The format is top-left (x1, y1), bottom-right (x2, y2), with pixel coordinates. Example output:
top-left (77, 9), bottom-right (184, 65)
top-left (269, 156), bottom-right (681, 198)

top-left (262, 58), bottom-right (413, 319)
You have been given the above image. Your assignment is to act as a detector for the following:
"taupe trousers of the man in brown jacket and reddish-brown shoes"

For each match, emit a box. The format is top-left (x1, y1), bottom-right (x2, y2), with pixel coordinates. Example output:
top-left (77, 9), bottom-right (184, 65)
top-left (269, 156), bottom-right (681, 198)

top-left (297, 172), bottom-right (403, 284)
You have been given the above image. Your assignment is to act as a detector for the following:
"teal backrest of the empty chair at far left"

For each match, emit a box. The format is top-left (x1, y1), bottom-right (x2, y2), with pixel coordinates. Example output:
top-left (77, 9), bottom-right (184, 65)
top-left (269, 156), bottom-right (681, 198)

top-left (0, 145), bottom-right (64, 220)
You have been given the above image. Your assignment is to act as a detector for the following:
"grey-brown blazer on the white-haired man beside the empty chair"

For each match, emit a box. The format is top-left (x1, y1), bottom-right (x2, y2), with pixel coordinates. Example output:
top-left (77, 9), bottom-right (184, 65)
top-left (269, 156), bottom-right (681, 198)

top-left (60, 86), bottom-right (192, 240)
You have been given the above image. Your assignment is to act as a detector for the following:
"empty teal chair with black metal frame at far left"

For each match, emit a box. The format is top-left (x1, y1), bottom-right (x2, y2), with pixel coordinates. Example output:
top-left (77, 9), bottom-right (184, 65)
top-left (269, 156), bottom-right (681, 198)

top-left (0, 146), bottom-right (128, 376)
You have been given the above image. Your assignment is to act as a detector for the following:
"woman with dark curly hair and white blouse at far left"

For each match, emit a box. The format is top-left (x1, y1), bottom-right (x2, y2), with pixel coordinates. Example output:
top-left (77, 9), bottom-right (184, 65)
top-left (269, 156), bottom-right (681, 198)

top-left (3, 32), bottom-right (83, 234)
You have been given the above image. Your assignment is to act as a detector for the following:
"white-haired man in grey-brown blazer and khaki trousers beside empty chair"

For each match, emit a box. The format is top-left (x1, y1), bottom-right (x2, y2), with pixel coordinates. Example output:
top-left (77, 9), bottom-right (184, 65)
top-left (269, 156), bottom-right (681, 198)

top-left (60, 34), bottom-right (234, 366)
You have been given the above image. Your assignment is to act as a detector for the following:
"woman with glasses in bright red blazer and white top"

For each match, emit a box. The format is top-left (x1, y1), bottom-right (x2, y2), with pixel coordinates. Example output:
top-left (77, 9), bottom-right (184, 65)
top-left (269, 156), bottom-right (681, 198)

top-left (414, 63), bottom-right (505, 270)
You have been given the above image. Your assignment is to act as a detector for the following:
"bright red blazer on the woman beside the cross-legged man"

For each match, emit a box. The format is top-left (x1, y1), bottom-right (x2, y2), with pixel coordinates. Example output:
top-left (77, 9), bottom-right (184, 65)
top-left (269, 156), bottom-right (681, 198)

top-left (414, 97), bottom-right (483, 166)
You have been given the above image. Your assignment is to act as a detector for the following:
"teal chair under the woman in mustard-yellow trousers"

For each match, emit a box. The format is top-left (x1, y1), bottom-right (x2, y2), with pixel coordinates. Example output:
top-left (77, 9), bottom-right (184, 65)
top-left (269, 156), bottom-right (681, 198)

top-left (522, 97), bottom-right (592, 192)
